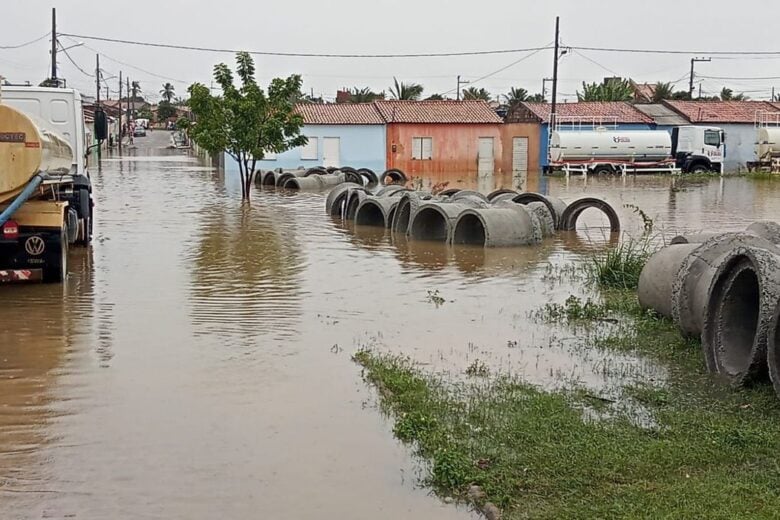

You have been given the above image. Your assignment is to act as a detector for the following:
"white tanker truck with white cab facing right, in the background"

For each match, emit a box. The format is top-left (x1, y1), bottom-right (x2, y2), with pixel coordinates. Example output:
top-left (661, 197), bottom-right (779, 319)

top-left (549, 126), bottom-right (726, 175)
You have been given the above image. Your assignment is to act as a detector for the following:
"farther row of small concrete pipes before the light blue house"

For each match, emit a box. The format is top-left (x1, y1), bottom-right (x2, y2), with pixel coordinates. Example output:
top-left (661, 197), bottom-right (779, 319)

top-left (255, 166), bottom-right (408, 191)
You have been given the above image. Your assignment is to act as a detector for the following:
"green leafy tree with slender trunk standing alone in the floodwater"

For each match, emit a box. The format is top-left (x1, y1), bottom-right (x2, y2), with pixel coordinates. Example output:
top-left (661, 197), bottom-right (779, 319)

top-left (189, 52), bottom-right (308, 202)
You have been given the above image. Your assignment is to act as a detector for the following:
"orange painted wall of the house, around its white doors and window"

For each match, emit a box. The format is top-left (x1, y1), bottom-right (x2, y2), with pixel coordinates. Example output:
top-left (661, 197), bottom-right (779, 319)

top-left (387, 123), bottom-right (539, 176)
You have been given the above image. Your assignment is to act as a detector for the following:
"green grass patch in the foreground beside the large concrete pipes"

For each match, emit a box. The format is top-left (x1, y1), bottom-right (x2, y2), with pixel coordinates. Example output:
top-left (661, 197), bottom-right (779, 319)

top-left (355, 290), bottom-right (780, 519)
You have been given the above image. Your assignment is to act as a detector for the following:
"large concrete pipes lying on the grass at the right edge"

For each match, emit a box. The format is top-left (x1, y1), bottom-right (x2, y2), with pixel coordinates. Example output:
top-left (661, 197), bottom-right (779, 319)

top-left (638, 221), bottom-right (780, 396)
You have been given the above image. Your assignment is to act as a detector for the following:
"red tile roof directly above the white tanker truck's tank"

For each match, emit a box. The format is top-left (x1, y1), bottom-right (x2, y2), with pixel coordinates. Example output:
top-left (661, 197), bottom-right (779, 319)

top-left (522, 101), bottom-right (653, 124)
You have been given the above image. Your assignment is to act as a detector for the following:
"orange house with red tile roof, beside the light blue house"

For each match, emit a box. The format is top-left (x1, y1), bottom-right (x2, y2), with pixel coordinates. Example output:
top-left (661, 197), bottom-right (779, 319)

top-left (374, 100), bottom-right (539, 176)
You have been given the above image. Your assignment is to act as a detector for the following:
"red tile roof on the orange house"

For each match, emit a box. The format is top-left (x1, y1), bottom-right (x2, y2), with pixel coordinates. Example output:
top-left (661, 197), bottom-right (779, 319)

top-left (374, 100), bottom-right (502, 124)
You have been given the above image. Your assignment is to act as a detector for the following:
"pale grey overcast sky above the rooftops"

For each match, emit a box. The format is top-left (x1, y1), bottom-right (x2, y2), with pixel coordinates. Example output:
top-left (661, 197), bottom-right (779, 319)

top-left (0, 0), bottom-right (780, 103)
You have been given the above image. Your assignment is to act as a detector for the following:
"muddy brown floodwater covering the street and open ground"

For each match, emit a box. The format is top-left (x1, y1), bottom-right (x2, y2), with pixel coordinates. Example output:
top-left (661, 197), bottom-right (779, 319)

top-left (0, 132), bottom-right (780, 519)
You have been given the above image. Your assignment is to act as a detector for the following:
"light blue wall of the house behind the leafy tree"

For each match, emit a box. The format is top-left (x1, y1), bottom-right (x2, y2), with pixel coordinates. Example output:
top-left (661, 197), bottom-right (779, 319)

top-left (225, 125), bottom-right (386, 173)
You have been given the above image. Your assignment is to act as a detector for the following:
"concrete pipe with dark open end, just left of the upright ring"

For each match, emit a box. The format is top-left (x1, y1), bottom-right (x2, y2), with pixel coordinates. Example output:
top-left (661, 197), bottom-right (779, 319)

top-left (452, 202), bottom-right (540, 247)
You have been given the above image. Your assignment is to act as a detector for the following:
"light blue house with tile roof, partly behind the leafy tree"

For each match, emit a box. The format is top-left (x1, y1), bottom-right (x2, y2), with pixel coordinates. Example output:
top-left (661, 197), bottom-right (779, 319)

top-left (225, 103), bottom-right (387, 173)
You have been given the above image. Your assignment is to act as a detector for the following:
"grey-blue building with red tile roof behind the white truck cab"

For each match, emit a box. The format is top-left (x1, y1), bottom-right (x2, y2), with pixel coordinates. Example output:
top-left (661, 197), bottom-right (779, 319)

top-left (664, 101), bottom-right (780, 172)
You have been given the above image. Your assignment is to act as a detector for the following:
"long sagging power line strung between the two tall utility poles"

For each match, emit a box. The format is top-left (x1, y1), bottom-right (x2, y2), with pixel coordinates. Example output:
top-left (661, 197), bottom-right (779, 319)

top-left (61, 33), bottom-right (552, 58)
